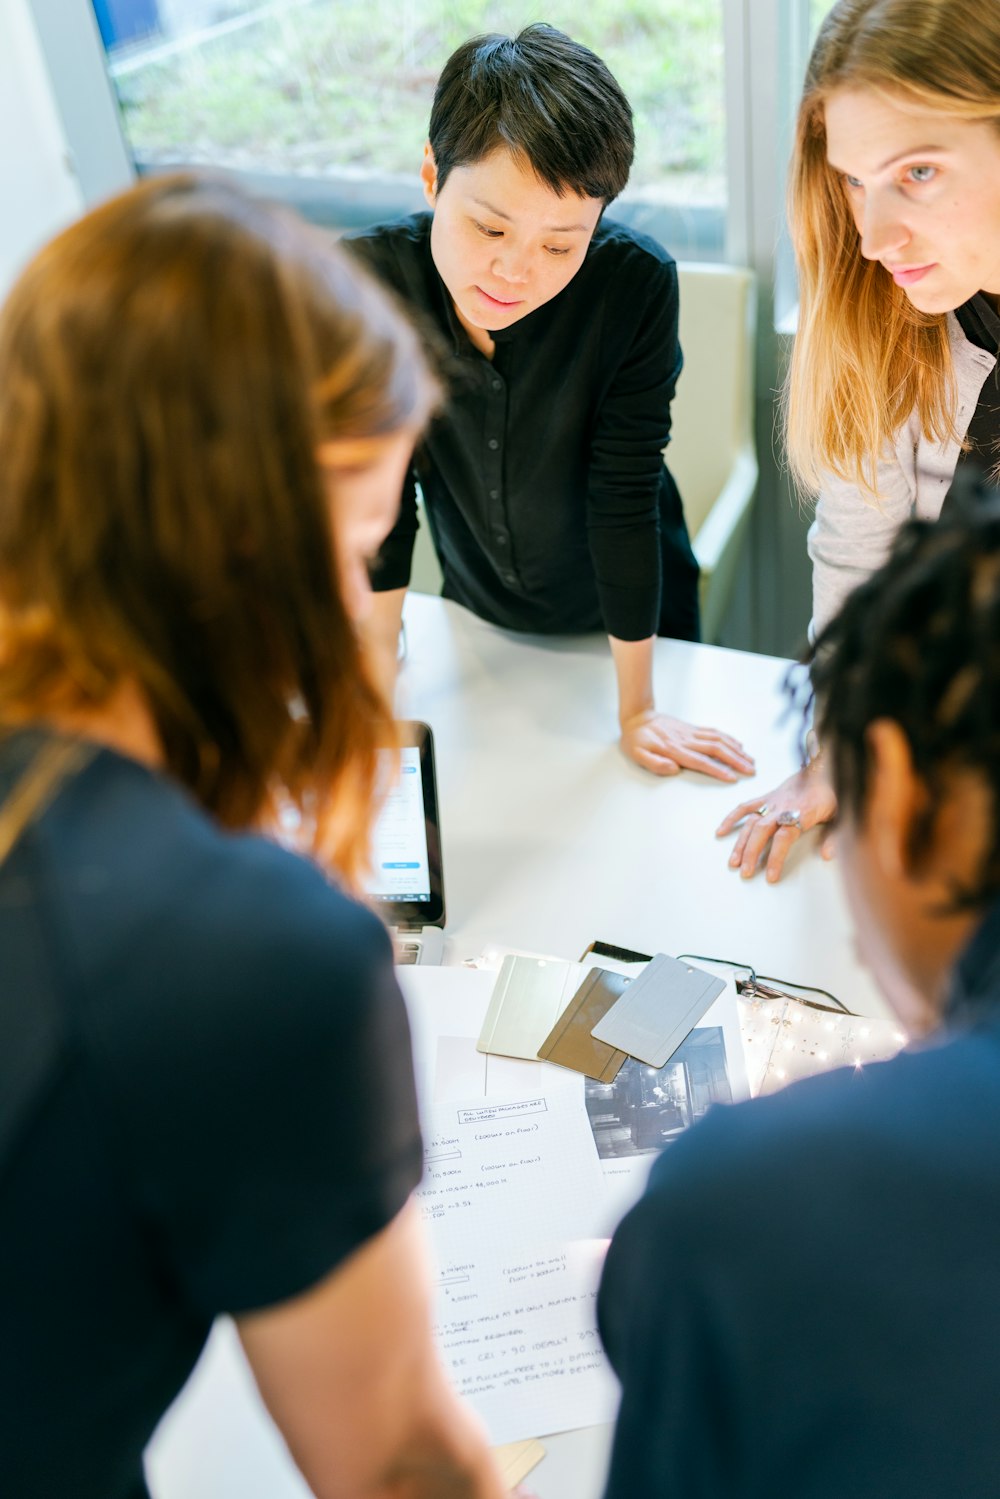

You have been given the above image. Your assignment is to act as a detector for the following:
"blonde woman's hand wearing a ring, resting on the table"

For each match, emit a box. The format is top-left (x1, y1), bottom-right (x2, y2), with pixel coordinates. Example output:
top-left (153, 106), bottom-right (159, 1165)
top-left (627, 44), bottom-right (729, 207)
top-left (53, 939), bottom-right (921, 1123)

top-left (715, 758), bottom-right (837, 884)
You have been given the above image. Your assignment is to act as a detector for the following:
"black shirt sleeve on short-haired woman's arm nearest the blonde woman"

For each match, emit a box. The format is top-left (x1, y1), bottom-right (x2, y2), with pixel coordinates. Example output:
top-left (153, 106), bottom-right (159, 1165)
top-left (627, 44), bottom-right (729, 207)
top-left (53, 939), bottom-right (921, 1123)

top-left (588, 258), bottom-right (682, 640)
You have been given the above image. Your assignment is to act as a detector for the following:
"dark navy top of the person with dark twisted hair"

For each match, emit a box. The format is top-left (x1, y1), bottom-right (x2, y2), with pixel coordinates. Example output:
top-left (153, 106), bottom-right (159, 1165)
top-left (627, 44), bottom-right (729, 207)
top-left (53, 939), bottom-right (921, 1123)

top-left (598, 904), bottom-right (1000, 1499)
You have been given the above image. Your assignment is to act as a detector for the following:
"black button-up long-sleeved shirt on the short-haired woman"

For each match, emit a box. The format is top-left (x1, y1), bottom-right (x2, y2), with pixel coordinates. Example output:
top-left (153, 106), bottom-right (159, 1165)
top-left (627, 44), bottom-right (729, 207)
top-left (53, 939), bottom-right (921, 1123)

top-left (345, 213), bottom-right (697, 640)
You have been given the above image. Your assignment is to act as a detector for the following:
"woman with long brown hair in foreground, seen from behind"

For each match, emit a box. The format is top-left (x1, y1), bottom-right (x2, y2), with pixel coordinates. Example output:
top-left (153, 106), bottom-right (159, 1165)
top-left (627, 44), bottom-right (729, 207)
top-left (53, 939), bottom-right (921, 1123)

top-left (0, 177), bottom-right (502, 1499)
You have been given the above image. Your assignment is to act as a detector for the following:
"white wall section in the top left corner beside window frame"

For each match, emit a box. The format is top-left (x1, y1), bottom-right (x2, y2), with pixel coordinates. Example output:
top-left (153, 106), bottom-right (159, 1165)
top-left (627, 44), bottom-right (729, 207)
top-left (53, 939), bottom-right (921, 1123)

top-left (0, 0), bottom-right (82, 297)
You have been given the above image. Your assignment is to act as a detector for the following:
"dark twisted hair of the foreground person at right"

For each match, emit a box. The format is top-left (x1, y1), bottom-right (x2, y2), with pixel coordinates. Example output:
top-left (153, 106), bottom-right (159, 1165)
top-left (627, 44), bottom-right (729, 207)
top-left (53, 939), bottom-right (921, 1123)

top-left (810, 469), bottom-right (1000, 910)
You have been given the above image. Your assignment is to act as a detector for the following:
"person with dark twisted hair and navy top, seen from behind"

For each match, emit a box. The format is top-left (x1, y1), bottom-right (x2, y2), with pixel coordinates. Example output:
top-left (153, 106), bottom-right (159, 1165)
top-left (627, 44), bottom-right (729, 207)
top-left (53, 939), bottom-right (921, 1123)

top-left (600, 480), bottom-right (1000, 1499)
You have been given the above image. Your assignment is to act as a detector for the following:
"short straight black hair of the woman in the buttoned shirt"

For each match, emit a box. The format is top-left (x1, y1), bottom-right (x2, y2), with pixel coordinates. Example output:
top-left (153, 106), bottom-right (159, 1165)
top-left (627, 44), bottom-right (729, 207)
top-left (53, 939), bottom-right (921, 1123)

top-left (429, 21), bottom-right (636, 204)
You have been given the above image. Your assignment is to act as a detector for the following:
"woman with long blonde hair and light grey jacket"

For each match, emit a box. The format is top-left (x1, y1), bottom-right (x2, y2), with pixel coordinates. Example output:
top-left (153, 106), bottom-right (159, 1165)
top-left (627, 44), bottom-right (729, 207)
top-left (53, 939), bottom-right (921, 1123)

top-left (720, 0), bottom-right (1000, 880)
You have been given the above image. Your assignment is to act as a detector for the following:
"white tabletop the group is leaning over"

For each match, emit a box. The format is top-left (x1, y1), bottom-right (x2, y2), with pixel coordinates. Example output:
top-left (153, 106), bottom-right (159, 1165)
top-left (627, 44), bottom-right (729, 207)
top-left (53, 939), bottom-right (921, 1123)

top-left (142, 595), bottom-right (886, 1499)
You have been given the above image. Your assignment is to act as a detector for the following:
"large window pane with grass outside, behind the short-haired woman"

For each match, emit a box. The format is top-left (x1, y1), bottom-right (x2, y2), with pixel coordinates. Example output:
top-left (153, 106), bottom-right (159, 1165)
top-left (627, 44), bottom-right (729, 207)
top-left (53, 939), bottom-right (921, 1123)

top-left (93, 0), bottom-right (726, 256)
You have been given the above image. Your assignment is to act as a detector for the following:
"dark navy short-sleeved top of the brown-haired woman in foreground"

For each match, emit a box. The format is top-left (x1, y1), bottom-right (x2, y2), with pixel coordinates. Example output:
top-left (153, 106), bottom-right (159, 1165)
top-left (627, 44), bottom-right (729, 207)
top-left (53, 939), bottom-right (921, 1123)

top-left (0, 736), bottom-right (421, 1499)
